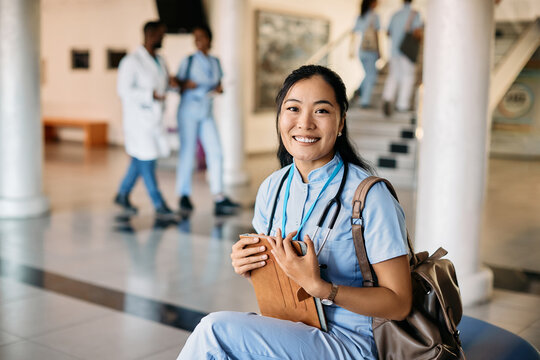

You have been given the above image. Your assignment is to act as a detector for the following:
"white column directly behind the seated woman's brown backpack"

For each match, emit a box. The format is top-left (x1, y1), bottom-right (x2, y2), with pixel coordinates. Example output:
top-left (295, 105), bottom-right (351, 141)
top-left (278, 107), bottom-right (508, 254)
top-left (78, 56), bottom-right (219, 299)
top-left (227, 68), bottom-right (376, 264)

top-left (416, 0), bottom-right (494, 305)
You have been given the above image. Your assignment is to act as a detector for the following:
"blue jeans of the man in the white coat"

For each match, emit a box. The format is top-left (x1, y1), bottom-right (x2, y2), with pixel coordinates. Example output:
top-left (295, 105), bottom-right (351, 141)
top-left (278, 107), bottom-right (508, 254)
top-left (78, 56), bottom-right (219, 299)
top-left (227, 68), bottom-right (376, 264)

top-left (118, 157), bottom-right (163, 209)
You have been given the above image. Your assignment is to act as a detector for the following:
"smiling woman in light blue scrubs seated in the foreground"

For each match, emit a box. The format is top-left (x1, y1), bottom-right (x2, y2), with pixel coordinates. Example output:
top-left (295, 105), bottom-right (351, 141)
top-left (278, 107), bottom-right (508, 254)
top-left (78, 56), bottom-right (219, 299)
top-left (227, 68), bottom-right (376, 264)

top-left (178, 65), bottom-right (412, 360)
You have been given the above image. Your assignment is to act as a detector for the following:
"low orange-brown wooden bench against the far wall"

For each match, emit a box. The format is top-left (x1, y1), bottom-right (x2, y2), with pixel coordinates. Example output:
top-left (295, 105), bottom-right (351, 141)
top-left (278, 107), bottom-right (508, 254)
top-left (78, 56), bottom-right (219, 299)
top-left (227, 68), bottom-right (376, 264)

top-left (43, 118), bottom-right (108, 147)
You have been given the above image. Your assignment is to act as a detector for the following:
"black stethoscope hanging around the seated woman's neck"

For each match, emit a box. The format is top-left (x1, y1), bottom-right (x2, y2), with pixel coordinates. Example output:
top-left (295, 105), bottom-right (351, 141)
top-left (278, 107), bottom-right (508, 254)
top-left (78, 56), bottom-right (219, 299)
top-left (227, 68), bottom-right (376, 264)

top-left (266, 162), bottom-right (349, 269)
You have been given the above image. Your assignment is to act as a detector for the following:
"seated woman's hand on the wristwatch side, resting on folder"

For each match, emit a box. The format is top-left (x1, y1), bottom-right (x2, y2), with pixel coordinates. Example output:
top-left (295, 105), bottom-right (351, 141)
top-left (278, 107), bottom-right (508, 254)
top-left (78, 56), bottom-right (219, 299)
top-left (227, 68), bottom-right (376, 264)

top-left (268, 229), bottom-right (326, 296)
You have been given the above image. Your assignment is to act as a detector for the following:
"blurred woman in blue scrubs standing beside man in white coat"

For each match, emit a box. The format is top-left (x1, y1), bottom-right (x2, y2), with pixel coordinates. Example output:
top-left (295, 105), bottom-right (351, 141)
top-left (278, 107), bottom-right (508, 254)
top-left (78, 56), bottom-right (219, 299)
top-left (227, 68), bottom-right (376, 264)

top-left (176, 25), bottom-right (239, 215)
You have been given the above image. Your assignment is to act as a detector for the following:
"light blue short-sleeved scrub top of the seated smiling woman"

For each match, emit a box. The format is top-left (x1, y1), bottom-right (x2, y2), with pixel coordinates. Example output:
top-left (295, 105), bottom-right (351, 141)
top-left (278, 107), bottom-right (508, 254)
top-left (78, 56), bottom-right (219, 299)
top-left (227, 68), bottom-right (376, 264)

top-left (253, 155), bottom-right (408, 354)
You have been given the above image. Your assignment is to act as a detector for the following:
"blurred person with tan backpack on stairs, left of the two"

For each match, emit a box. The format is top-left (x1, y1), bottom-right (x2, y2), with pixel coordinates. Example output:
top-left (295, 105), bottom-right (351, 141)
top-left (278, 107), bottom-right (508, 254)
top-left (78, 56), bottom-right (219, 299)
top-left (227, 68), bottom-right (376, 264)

top-left (350, 0), bottom-right (381, 108)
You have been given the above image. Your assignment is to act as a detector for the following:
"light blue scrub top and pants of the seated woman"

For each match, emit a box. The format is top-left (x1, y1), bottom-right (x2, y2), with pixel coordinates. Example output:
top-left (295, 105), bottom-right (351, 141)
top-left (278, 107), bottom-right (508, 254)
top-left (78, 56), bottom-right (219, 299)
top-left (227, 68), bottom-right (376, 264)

top-left (178, 155), bottom-right (408, 360)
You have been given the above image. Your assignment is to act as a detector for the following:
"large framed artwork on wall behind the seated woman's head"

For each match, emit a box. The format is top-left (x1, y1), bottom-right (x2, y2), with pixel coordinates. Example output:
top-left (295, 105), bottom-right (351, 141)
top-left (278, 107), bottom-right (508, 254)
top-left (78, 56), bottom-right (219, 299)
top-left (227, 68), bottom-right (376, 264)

top-left (255, 10), bottom-right (330, 111)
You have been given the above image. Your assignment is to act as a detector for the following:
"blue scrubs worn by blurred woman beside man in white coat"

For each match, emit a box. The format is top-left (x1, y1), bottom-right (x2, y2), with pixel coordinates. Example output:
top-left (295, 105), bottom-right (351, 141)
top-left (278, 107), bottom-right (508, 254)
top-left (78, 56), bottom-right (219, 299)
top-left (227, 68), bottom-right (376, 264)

top-left (176, 51), bottom-right (223, 196)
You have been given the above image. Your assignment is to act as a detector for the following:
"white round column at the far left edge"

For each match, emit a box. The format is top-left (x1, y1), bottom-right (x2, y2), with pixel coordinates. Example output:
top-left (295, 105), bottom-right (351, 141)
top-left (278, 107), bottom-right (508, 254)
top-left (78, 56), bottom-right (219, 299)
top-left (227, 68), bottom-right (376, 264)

top-left (0, 0), bottom-right (49, 218)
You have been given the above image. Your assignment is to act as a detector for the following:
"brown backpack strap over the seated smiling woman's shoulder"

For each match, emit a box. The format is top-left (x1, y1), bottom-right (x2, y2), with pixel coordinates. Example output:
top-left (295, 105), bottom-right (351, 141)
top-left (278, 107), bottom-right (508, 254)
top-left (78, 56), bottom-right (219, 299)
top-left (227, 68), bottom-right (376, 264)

top-left (351, 176), bottom-right (418, 287)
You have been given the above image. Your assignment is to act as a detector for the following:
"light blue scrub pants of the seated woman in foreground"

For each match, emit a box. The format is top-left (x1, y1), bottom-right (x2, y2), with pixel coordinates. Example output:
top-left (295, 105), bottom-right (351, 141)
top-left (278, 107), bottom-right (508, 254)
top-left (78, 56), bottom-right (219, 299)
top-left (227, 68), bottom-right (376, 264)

top-left (177, 311), bottom-right (374, 360)
